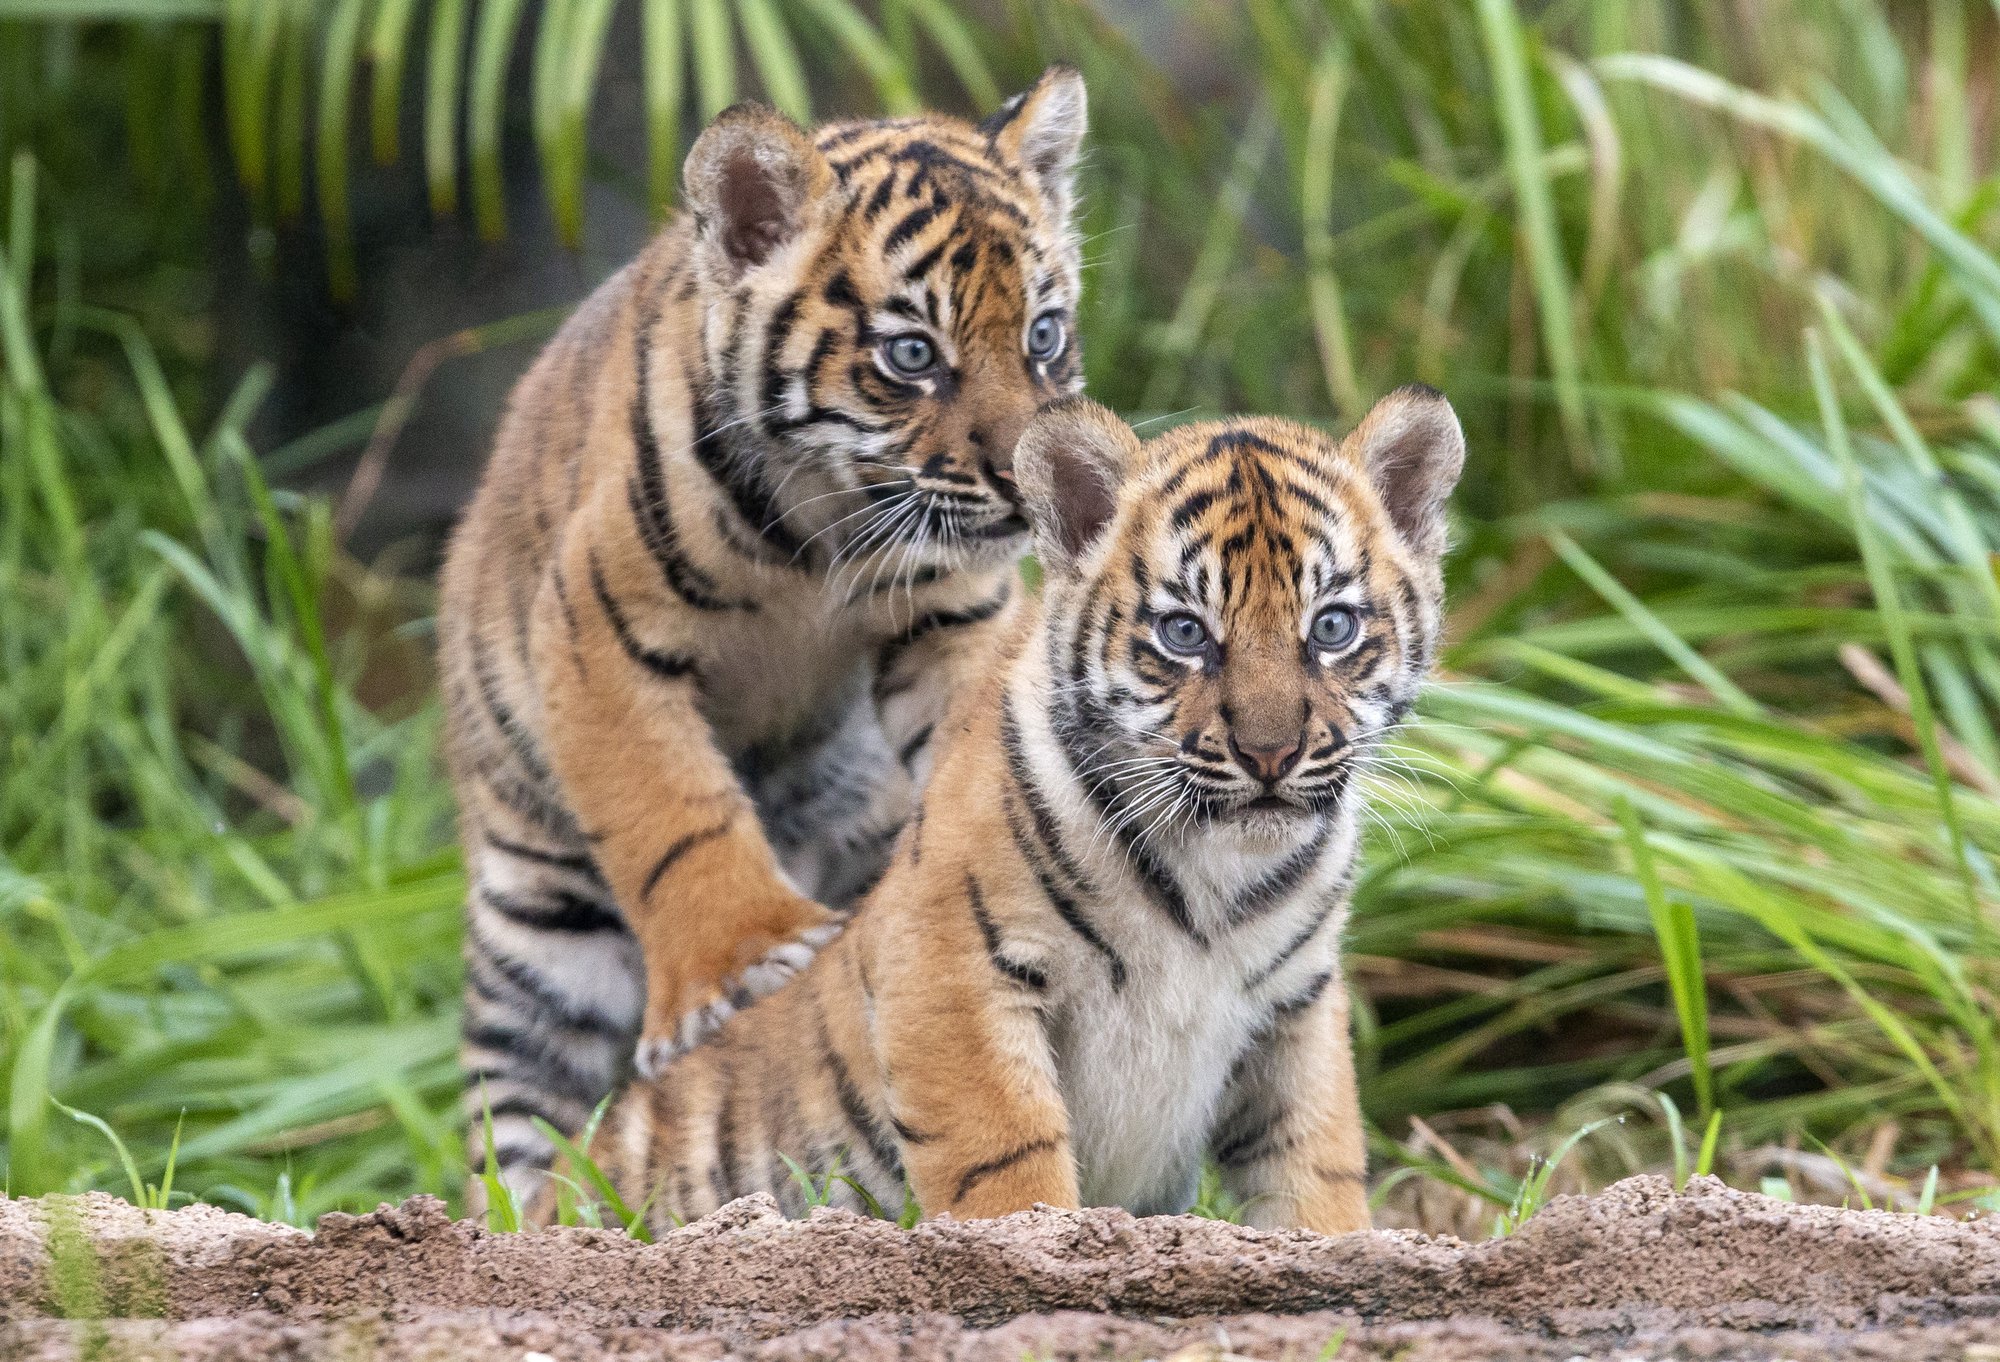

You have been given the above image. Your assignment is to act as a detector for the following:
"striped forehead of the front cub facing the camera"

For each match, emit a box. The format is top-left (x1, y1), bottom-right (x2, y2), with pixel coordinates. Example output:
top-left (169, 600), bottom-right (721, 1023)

top-left (1126, 418), bottom-right (1394, 604)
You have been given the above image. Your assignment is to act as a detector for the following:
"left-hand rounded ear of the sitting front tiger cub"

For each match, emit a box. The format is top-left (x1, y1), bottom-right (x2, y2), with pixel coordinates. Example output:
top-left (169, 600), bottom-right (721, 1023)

top-left (1014, 398), bottom-right (1138, 570)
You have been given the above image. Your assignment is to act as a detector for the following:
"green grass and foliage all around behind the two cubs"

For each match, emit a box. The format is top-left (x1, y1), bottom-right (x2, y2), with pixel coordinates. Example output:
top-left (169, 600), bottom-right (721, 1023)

top-left (0, 0), bottom-right (2000, 1226)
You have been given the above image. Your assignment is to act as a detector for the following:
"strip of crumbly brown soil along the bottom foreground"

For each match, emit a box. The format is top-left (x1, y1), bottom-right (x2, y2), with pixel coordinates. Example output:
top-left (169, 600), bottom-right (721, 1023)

top-left (0, 1178), bottom-right (2000, 1362)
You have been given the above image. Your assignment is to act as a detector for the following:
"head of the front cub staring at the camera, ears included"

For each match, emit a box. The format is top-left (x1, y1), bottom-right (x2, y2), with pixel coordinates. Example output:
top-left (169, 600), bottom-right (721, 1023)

top-left (1020, 388), bottom-right (1464, 838)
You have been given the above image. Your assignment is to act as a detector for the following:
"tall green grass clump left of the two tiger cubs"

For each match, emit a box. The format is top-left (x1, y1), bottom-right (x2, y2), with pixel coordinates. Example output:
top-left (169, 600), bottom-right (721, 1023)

top-left (0, 152), bottom-right (458, 1214)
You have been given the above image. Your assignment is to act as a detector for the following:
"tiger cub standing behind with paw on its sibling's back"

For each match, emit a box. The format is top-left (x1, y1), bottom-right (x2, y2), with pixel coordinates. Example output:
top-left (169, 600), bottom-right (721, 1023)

top-left (438, 68), bottom-right (1084, 1190)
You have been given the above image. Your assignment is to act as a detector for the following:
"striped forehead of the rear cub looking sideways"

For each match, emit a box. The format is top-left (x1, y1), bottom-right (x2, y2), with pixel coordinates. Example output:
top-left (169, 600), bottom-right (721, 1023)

top-left (816, 114), bottom-right (1078, 328)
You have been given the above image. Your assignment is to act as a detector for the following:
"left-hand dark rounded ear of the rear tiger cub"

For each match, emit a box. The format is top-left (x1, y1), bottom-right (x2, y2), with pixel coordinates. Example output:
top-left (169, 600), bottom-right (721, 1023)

top-left (682, 104), bottom-right (834, 274)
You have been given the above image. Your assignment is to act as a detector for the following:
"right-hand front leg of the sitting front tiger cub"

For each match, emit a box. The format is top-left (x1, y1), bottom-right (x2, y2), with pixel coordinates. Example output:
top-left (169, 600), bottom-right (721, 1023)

top-left (1212, 964), bottom-right (1368, 1234)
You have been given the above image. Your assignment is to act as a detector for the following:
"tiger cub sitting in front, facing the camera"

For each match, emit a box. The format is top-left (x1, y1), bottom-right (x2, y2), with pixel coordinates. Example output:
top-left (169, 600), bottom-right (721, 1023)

top-left (584, 388), bottom-right (1464, 1232)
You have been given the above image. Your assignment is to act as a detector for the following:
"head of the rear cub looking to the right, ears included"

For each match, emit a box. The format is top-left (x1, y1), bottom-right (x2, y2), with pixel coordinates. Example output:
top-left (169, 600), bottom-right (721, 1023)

top-left (686, 68), bottom-right (1084, 572)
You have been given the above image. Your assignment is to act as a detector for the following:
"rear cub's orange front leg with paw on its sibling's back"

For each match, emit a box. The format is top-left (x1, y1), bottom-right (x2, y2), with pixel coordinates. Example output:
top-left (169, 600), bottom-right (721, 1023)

top-left (534, 504), bottom-right (840, 1076)
